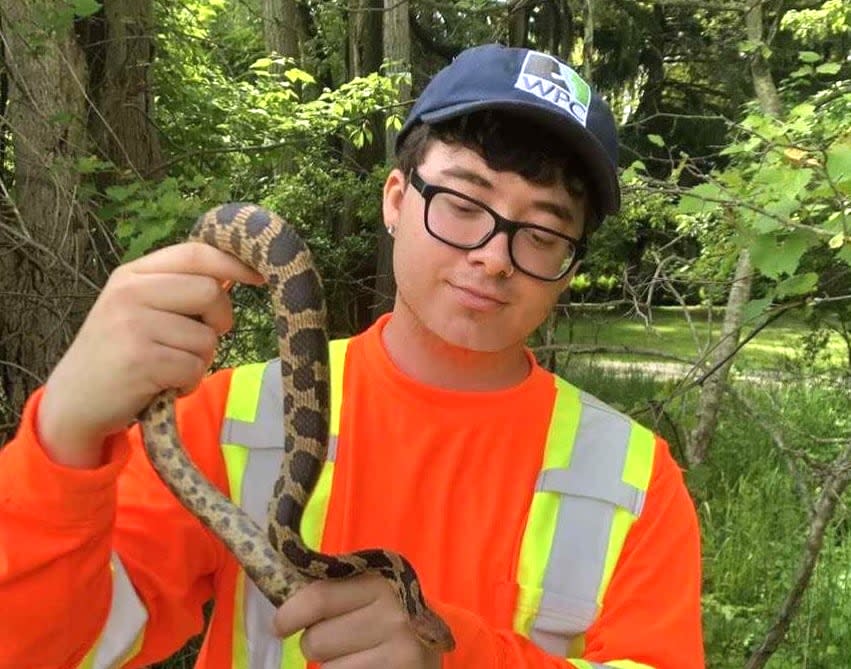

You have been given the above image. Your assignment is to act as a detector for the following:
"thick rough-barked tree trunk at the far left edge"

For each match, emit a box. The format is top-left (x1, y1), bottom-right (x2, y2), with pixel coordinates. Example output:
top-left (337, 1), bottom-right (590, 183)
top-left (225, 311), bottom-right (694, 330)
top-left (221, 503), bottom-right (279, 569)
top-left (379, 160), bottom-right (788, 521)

top-left (0, 0), bottom-right (97, 442)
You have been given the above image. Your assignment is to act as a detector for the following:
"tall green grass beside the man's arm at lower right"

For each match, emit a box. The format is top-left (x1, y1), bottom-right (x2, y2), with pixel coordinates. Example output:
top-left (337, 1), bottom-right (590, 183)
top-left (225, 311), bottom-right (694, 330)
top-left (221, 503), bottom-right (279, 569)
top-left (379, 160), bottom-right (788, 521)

top-left (566, 354), bottom-right (851, 669)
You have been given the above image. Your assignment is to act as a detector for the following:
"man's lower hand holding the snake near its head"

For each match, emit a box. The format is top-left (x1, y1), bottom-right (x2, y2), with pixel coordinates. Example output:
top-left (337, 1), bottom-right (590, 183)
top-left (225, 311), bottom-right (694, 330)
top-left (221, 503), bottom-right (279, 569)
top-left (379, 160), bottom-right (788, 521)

top-left (274, 574), bottom-right (440, 669)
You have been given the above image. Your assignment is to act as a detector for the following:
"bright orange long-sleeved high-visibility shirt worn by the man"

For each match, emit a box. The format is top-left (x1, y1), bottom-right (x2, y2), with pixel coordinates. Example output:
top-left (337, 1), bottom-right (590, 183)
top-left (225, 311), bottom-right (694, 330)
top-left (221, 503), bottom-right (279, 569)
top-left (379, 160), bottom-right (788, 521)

top-left (0, 318), bottom-right (704, 669)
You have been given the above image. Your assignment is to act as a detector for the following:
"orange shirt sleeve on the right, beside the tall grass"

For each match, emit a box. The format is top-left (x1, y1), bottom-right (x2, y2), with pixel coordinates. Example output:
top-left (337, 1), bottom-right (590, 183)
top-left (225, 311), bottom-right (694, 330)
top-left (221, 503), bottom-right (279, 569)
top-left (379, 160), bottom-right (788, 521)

top-left (435, 439), bottom-right (705, 669)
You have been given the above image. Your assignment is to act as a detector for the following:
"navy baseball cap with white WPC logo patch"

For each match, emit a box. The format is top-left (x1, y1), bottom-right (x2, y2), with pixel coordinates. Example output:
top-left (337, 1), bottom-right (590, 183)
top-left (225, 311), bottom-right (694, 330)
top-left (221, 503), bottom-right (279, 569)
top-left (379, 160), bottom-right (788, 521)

top-left (396, 44), bottom-right (621, 218)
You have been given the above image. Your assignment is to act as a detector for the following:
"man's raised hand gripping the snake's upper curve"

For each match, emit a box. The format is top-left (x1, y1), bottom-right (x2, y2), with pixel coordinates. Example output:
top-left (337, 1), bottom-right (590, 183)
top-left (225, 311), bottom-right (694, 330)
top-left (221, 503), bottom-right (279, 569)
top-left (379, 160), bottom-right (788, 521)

top-left (38, 242), bottom-right (263, 468)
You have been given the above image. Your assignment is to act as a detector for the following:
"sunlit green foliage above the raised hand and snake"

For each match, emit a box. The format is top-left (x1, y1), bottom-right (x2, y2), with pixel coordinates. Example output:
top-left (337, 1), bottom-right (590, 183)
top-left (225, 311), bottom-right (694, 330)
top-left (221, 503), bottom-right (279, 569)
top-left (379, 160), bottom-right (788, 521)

top-left (100, 1), bottom-right (406, 292)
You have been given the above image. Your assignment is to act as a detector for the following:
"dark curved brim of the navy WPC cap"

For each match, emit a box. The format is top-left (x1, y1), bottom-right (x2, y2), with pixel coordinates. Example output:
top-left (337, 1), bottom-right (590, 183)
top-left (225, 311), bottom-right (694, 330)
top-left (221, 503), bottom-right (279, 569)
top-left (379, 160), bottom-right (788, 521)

top-left (420, 99), bottom-right (620, 215)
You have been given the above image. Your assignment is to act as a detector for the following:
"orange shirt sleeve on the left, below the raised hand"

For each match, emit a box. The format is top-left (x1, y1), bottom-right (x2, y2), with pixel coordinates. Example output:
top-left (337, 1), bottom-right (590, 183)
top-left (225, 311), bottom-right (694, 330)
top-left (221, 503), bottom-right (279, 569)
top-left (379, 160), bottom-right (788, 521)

top-left (0, 371), bottom-right (230, 669)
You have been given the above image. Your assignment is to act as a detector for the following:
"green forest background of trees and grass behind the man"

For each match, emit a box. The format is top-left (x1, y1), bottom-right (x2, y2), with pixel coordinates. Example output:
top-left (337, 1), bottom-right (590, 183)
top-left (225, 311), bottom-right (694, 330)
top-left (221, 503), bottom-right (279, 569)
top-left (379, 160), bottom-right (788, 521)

top-left (0, 0), bottom-right (851, 669)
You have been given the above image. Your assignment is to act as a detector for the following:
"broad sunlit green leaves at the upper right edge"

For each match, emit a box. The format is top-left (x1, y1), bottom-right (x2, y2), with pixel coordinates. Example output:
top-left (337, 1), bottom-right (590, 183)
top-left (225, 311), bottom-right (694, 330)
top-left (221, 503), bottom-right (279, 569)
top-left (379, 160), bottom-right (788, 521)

top-left (678, 79), bottom-right (851, 318)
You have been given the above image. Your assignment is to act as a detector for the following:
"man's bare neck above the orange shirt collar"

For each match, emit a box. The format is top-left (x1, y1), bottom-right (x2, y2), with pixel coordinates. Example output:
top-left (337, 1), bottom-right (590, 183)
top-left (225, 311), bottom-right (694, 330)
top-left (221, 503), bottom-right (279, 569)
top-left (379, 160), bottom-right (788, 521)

top-left (382, 302), bottom-right (531, 391)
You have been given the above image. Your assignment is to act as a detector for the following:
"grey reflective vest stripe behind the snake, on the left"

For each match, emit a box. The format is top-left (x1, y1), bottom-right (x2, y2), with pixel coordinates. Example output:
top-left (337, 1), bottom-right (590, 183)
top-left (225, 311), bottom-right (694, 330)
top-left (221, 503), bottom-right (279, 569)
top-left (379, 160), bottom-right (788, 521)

top-left (221, 358), bottom-right (337, 669)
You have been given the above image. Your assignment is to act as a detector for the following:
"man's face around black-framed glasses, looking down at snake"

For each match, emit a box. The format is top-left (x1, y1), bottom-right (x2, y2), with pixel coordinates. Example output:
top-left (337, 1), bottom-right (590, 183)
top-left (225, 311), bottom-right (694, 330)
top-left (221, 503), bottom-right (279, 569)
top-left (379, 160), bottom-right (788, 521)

top-left (384, 142), bottom-right (584, 352)
